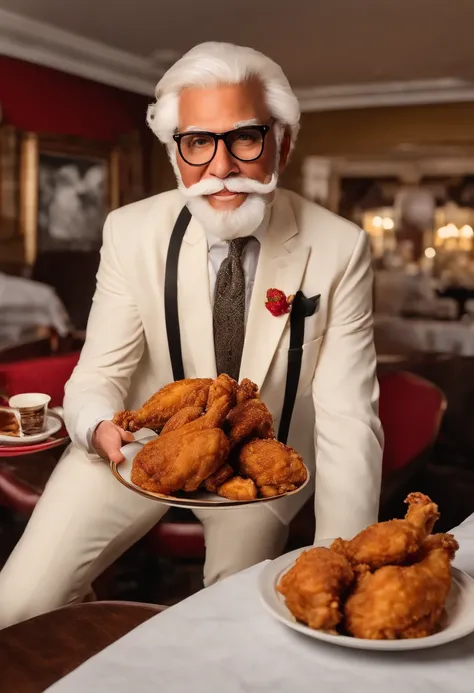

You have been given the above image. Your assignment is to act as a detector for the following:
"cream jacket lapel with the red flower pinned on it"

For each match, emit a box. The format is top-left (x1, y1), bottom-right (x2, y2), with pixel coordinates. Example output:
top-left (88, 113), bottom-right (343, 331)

top-left (240, 193), bottom-right (310, 388)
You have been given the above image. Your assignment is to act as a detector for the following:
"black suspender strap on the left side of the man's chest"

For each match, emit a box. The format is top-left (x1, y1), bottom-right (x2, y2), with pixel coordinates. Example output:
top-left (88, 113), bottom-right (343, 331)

top-left (164, 207), bottom-right (191, 380)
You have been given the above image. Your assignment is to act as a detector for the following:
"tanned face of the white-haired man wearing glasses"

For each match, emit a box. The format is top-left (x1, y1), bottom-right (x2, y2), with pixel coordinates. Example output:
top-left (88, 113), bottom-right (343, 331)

top-left (177, 80), bottom-right (289, 212)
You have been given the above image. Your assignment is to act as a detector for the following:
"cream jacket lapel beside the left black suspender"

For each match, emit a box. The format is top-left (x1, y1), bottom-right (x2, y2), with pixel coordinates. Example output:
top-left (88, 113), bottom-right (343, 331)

top-left (178, 217), bottom-right (217, 378)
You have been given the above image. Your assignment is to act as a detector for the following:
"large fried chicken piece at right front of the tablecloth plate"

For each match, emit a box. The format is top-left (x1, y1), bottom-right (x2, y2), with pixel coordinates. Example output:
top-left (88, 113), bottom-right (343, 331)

top-left (345, 534), bottom-right (459, 640)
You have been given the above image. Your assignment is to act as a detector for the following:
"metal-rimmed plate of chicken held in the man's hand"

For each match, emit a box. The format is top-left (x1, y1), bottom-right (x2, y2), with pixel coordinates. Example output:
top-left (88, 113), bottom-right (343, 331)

top-left (110, 431), bottom-right (310, 510)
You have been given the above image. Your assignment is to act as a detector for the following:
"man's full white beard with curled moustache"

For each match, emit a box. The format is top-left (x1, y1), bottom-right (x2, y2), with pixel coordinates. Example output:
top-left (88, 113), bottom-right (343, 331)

top-left (170, 152), bottom-right (278, 241)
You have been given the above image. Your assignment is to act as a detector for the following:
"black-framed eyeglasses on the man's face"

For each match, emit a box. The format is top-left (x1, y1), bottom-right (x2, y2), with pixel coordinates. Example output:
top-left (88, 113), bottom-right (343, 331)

top-left (173, 119), bottom-right (274, 166)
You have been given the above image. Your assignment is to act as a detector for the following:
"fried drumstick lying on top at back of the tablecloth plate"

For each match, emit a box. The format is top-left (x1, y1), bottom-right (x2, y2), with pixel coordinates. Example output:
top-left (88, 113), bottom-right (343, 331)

top-left (331, 493), bottom-right (439, 570)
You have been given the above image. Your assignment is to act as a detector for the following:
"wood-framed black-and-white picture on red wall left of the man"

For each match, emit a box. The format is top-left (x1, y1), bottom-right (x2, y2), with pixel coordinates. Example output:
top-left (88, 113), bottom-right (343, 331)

top-left (20, 132), bottom-right (141, 265)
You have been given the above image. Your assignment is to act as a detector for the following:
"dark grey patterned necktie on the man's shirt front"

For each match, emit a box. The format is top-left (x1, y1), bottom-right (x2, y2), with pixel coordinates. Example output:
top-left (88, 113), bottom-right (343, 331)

top-left (213, 236), bottom-right (250, 380)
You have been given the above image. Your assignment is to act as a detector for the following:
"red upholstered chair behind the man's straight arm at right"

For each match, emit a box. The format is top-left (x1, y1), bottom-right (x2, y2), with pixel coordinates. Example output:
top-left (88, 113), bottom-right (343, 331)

top-left (290, 371), bottom-right (446, 548)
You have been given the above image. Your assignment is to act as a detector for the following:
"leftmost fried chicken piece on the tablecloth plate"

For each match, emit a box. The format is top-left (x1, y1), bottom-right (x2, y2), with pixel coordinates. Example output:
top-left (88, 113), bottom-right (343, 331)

top-left (277, 547), bottom-right (354, 631)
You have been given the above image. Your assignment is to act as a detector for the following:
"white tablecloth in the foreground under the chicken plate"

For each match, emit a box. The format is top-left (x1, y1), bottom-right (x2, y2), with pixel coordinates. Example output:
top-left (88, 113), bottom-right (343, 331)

top-left (48, 517), bottom-right (474, 693)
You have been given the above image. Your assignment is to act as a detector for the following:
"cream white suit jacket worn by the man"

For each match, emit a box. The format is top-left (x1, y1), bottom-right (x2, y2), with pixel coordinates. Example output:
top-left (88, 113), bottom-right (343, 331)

top-left (64, 190), bottom-right (382, 538)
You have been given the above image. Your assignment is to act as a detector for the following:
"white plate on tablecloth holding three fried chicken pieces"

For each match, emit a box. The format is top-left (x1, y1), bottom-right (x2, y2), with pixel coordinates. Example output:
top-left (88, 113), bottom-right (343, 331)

top-left (258, 540), bottom-right (474, 650)
